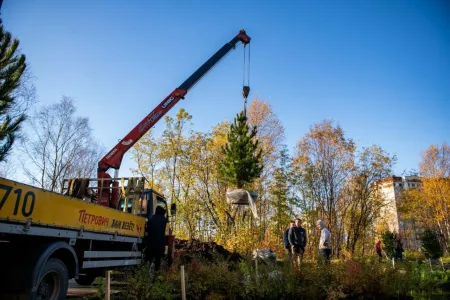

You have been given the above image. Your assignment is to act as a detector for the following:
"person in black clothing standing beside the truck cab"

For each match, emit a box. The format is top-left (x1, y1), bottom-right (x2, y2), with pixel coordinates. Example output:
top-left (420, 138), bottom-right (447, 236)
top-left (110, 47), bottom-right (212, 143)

top-left (146, 206), bottom-right (168, 271)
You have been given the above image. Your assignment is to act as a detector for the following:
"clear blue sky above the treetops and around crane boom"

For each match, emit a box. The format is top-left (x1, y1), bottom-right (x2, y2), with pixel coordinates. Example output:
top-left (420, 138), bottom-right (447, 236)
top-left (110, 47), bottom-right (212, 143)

top-left (2, 0), bottom-right (450, 176)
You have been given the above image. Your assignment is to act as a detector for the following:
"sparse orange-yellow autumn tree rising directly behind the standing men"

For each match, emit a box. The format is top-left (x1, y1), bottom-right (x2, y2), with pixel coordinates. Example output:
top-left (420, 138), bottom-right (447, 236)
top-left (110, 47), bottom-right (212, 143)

top-left (294, 120), bottom-right (355, 255)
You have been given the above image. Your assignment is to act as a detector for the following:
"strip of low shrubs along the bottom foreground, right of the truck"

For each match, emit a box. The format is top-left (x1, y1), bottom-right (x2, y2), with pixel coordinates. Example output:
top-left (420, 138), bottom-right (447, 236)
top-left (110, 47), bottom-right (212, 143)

top-left (120, 257), bottom-right (450, 300)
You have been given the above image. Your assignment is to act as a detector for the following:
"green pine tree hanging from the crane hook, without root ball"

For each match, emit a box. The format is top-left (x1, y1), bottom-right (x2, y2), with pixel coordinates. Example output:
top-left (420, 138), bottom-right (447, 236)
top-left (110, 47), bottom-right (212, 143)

top-left (219, 111), bottom-right (263, 189)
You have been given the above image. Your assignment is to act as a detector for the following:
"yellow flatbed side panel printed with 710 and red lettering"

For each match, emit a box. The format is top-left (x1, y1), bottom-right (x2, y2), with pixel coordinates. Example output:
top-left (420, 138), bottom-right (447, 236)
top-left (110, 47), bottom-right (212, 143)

top-left (0, 177), bottom-right (146, 238)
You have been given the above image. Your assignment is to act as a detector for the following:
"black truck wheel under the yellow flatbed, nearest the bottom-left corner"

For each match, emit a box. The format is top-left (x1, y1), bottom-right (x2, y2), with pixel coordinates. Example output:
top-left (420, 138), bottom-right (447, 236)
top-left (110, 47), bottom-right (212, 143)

top-left (32, 258), bottom-right (69, 300)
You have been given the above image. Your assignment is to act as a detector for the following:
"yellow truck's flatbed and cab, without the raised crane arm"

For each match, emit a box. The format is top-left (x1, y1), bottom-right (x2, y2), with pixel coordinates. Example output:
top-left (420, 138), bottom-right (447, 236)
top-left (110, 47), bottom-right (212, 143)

top-left (0, 178), bottom-right (167, 299)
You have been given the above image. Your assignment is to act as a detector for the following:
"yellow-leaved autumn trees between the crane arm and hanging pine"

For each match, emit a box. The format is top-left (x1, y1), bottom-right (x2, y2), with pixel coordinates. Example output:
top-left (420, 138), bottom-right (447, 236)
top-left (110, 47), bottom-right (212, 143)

top-left (128, 109), bottom-right (264, 252)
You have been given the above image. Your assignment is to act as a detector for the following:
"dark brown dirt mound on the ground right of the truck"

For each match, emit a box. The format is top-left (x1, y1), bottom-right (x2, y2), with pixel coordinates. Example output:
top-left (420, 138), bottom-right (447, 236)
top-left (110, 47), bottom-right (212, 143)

top-left (175, 239), bottom-right (242, 262)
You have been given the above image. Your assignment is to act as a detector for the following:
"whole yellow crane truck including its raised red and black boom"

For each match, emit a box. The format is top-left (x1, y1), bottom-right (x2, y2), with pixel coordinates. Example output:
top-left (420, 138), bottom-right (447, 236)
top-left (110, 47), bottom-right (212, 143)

top-left (0, 30), bottom-right (250, 299)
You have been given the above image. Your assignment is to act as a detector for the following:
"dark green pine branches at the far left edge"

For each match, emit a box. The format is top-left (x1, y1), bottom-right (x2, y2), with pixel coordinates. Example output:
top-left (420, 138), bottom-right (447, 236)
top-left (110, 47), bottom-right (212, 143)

top-left (0, 25), bottom-right (26, 162)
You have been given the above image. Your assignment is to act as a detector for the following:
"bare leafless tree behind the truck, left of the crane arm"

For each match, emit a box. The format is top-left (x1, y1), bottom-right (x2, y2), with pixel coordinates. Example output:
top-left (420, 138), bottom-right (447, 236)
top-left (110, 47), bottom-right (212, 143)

top-left (22, 97), bottom-right (104, 191)
